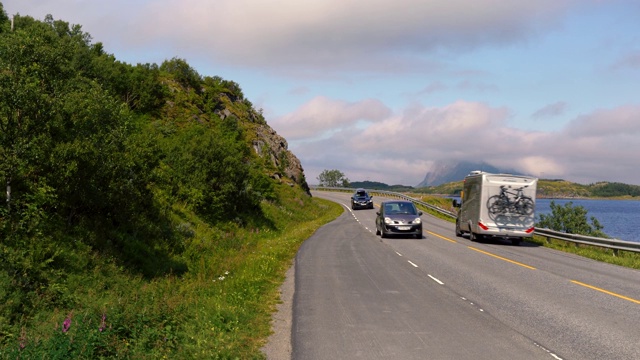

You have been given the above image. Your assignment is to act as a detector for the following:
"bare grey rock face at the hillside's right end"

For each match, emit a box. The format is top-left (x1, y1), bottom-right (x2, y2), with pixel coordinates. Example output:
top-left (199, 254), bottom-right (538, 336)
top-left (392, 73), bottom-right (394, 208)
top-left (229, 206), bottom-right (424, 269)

top-left (253, 124), bottom-right (311, 194)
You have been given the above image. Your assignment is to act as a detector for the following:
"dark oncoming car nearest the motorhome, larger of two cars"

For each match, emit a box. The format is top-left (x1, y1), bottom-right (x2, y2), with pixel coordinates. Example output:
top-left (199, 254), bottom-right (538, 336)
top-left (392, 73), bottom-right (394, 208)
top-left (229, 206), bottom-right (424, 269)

top-left (376, 200), bottom-right (422, 239)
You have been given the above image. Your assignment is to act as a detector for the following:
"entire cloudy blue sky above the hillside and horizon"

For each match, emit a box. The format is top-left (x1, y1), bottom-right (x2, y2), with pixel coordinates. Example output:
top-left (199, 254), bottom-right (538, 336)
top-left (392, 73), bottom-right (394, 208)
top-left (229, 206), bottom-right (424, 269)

top-left (0, 0), bottom-right (640, 186)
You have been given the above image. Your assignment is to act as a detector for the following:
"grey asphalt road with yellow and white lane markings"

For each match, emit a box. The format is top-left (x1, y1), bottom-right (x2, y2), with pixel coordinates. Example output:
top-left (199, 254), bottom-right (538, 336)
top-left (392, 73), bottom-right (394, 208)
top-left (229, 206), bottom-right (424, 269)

top-left (271, 192), bottom-right (640, 359)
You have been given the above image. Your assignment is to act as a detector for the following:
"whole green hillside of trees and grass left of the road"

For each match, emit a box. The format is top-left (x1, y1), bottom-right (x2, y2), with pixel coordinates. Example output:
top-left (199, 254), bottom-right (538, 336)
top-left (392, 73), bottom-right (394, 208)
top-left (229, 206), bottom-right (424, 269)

top-left (0, 3), bottom-right (330, 359)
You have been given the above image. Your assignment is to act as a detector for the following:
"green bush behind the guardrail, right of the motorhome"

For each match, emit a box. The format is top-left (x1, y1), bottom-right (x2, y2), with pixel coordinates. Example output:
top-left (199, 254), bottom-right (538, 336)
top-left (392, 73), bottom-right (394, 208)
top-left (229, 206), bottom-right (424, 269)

top-left (536, 201), bottom-right (607, 237)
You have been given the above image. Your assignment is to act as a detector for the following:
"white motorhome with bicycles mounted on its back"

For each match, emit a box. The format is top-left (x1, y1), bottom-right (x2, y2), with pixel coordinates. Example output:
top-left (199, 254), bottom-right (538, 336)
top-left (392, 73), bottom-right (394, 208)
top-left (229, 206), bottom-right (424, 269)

top-left (454, 171), bottom-right (538, 245)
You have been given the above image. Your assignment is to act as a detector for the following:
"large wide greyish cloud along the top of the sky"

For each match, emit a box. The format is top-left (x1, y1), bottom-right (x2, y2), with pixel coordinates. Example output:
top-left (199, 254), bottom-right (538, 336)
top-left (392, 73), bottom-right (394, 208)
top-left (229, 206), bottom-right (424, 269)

top-left (124, 0), bottom-right (575, 71)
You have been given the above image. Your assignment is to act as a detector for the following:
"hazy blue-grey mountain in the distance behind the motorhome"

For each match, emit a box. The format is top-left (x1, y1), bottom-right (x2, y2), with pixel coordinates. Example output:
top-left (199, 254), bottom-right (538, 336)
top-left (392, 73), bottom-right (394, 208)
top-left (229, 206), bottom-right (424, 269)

top-left (416, 161), bottom-right (520, 188)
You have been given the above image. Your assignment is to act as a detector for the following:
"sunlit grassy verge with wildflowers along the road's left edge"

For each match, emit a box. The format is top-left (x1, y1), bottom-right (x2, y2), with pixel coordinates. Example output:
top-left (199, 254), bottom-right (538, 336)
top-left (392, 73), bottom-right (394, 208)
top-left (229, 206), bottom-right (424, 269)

top-left (0, 185), bottom-right (343, 359)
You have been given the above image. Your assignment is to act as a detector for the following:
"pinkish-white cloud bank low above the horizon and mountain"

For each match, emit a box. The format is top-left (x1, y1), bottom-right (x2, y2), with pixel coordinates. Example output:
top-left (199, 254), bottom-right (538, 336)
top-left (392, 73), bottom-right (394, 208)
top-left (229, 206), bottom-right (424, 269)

top-left (289, 101), bottom-right (640, 185)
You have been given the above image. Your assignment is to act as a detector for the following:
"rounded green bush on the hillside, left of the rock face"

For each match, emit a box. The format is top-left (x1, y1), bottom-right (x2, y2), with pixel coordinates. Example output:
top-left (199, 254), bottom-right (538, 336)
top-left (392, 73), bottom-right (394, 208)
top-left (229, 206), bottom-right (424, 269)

top-left (158, 122), bottom-right (269, 222)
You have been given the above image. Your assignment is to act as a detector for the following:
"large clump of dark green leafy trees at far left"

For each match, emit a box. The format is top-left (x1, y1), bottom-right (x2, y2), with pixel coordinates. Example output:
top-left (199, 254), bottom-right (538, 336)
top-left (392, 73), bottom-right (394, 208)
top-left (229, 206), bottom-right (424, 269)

top-left (0, 12), bottom-right (170, 282)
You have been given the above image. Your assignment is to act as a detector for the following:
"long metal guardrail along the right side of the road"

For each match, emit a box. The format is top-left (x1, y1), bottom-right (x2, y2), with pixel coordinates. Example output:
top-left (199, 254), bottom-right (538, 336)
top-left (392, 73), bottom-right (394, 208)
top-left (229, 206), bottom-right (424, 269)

top-left (311, 186), bottom-right (640, 255)
